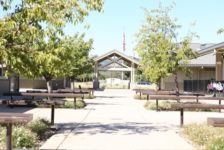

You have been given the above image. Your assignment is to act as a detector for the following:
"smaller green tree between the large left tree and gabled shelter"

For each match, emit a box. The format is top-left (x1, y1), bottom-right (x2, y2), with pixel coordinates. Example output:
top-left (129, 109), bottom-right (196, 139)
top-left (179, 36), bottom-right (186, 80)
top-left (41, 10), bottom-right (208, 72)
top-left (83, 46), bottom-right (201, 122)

top-left (58, 35), bottom-right (94, 88)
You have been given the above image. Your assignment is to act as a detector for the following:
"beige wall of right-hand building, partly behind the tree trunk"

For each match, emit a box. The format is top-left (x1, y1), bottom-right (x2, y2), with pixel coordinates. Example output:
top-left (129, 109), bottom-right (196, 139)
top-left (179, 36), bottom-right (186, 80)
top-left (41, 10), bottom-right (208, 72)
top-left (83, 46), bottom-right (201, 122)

top-left (162, 68), bottom-right (215, 90)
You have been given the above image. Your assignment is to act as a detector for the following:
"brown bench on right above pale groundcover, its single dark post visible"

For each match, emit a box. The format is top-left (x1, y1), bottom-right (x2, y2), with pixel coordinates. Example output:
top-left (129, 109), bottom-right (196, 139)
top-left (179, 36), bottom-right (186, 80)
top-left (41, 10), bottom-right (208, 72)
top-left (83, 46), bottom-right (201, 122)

top-left (171, 103), bottom-right (224, 127)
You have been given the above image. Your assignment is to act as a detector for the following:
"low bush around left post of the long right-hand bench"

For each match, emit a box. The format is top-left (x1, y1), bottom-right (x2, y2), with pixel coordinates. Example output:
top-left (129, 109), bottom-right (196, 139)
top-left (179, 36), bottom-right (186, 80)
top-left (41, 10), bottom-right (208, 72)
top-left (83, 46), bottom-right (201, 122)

top-left (145, 101), bottom-right (171, 110)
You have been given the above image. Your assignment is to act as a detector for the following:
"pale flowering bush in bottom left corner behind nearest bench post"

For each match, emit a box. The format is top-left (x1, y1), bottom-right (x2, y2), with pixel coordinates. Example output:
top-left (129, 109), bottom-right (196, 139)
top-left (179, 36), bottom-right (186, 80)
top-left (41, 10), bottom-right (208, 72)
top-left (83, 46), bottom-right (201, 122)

top-left (1, 126), bottom-right (37, 148)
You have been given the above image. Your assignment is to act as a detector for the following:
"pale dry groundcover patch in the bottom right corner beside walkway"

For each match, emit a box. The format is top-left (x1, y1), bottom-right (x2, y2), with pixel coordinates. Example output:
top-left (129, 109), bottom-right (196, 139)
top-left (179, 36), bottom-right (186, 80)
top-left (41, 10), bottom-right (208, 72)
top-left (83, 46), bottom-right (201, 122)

top-left (181, 124), bottom-right (224, 150)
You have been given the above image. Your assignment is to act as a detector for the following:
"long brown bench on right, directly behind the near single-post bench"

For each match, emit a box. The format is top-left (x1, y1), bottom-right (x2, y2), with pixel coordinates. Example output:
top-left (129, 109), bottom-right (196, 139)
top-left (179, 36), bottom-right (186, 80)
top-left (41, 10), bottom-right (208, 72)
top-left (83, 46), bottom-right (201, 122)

top-left (149, 95), bottom-right (224, 111)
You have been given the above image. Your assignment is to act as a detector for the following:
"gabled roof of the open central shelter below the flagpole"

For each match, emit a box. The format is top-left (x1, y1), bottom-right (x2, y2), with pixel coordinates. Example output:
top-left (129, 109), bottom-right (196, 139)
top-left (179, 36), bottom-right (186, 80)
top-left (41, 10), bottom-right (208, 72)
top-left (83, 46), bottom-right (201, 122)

top-left (95, 50), bottom-right (139, 65)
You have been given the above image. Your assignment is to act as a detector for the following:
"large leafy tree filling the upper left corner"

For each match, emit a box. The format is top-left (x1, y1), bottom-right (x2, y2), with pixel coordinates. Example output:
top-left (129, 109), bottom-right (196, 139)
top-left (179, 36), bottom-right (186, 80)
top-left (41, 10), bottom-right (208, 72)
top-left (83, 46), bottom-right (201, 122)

top-left (0, 0), bottom-right (103, 90)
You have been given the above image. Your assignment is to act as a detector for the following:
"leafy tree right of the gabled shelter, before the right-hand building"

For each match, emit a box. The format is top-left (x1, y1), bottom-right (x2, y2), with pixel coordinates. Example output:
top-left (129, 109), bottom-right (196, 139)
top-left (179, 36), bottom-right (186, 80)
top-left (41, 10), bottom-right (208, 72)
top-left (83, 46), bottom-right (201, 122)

top-left (135, 5), bottom-right (195, 93)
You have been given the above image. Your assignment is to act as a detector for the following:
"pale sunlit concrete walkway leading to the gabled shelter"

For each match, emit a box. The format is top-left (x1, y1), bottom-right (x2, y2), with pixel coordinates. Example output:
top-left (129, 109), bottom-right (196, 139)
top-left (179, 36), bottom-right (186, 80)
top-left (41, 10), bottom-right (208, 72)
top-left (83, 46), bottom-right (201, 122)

top-left (38, 90), bottom-right (194, 150)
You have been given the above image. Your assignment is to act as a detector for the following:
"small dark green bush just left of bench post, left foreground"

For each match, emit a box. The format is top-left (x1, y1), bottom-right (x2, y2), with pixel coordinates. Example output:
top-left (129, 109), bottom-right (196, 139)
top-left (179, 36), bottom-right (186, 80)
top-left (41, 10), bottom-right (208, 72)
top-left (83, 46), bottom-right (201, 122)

top-left (27, 119), bottom-right (50, 139)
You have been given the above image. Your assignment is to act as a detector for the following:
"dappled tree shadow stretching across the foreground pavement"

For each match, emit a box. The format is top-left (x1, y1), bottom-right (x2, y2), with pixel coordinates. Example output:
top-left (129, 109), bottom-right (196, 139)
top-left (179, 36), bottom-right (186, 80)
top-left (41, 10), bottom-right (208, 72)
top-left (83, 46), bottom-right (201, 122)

top-left (56, 122), bottom-right (178, 135)
